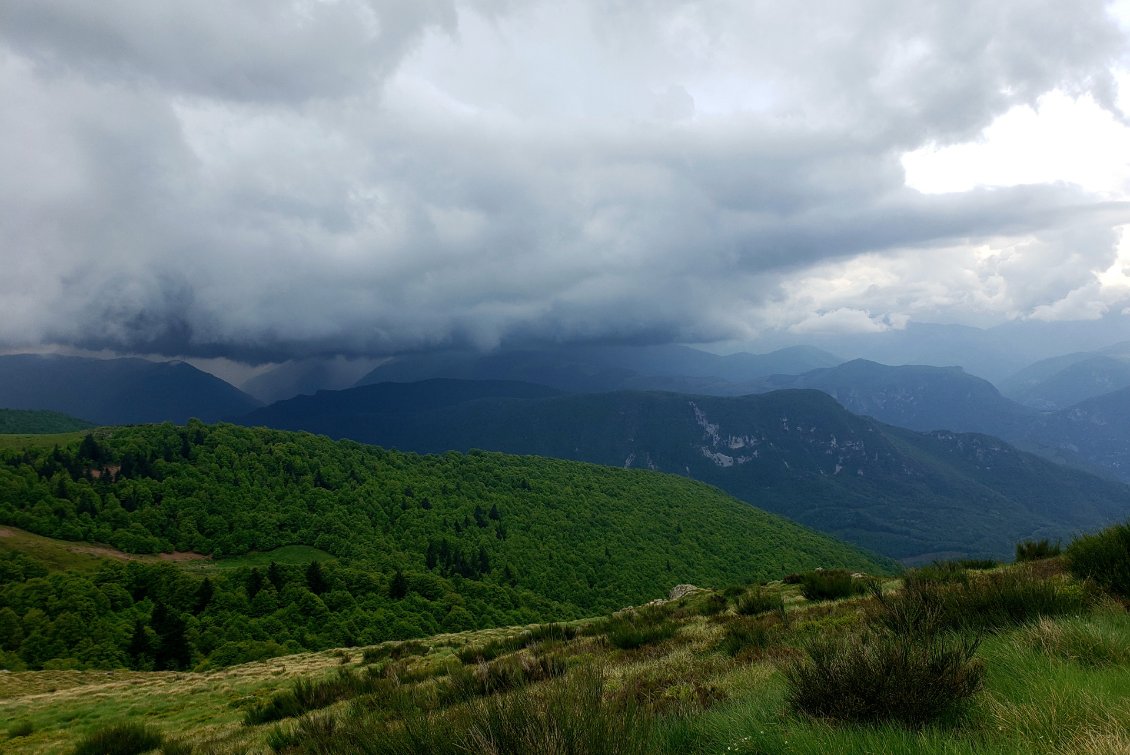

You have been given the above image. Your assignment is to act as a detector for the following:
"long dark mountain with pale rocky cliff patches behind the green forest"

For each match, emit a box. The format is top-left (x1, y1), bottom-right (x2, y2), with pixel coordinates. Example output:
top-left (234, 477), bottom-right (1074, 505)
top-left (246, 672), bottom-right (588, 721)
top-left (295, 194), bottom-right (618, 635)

top-left (233, 381), bottom-right (1130, 561)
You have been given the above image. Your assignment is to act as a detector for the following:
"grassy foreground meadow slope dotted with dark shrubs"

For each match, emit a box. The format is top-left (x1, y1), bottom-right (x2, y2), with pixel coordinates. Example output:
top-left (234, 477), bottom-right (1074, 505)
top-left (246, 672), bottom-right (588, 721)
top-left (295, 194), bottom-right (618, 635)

top-left (0, 553), bottom-right (1130, 754)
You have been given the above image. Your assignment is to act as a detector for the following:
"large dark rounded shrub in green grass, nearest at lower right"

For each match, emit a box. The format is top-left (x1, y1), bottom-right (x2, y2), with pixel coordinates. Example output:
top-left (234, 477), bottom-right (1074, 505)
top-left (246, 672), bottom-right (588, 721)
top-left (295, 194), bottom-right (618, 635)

top-left (784, 631), bottom-right (984, 727)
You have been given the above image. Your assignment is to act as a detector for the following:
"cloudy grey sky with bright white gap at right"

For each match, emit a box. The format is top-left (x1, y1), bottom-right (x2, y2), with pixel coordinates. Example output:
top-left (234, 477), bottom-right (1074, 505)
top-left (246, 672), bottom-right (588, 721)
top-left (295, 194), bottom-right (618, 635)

top-left (0, 0), bottom-right (1130, 364)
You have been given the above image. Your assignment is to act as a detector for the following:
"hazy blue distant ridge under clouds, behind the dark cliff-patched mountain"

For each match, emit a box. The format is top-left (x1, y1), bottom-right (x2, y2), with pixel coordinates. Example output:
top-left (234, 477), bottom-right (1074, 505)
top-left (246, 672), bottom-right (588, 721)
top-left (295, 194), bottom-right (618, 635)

top-left (357, 345), bottom-right (842, 396)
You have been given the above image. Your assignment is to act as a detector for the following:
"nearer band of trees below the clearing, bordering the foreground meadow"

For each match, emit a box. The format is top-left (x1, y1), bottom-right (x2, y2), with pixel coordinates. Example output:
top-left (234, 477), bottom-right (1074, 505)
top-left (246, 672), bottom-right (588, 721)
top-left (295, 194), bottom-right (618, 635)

top-left (0, 553), bottom-right (565, 670)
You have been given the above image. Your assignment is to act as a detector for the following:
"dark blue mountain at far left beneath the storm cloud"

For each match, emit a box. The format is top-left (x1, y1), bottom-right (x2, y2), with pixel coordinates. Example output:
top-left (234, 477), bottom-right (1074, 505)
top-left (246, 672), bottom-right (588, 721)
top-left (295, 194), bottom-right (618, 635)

top-left (0, 354), bottom-right (259, 425)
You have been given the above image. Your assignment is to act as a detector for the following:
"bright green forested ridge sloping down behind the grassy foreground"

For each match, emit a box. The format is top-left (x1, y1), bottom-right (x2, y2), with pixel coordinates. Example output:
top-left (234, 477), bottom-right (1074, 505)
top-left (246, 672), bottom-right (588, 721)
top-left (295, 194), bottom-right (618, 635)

top-left (0, 422), bottom-right (890, 669)
